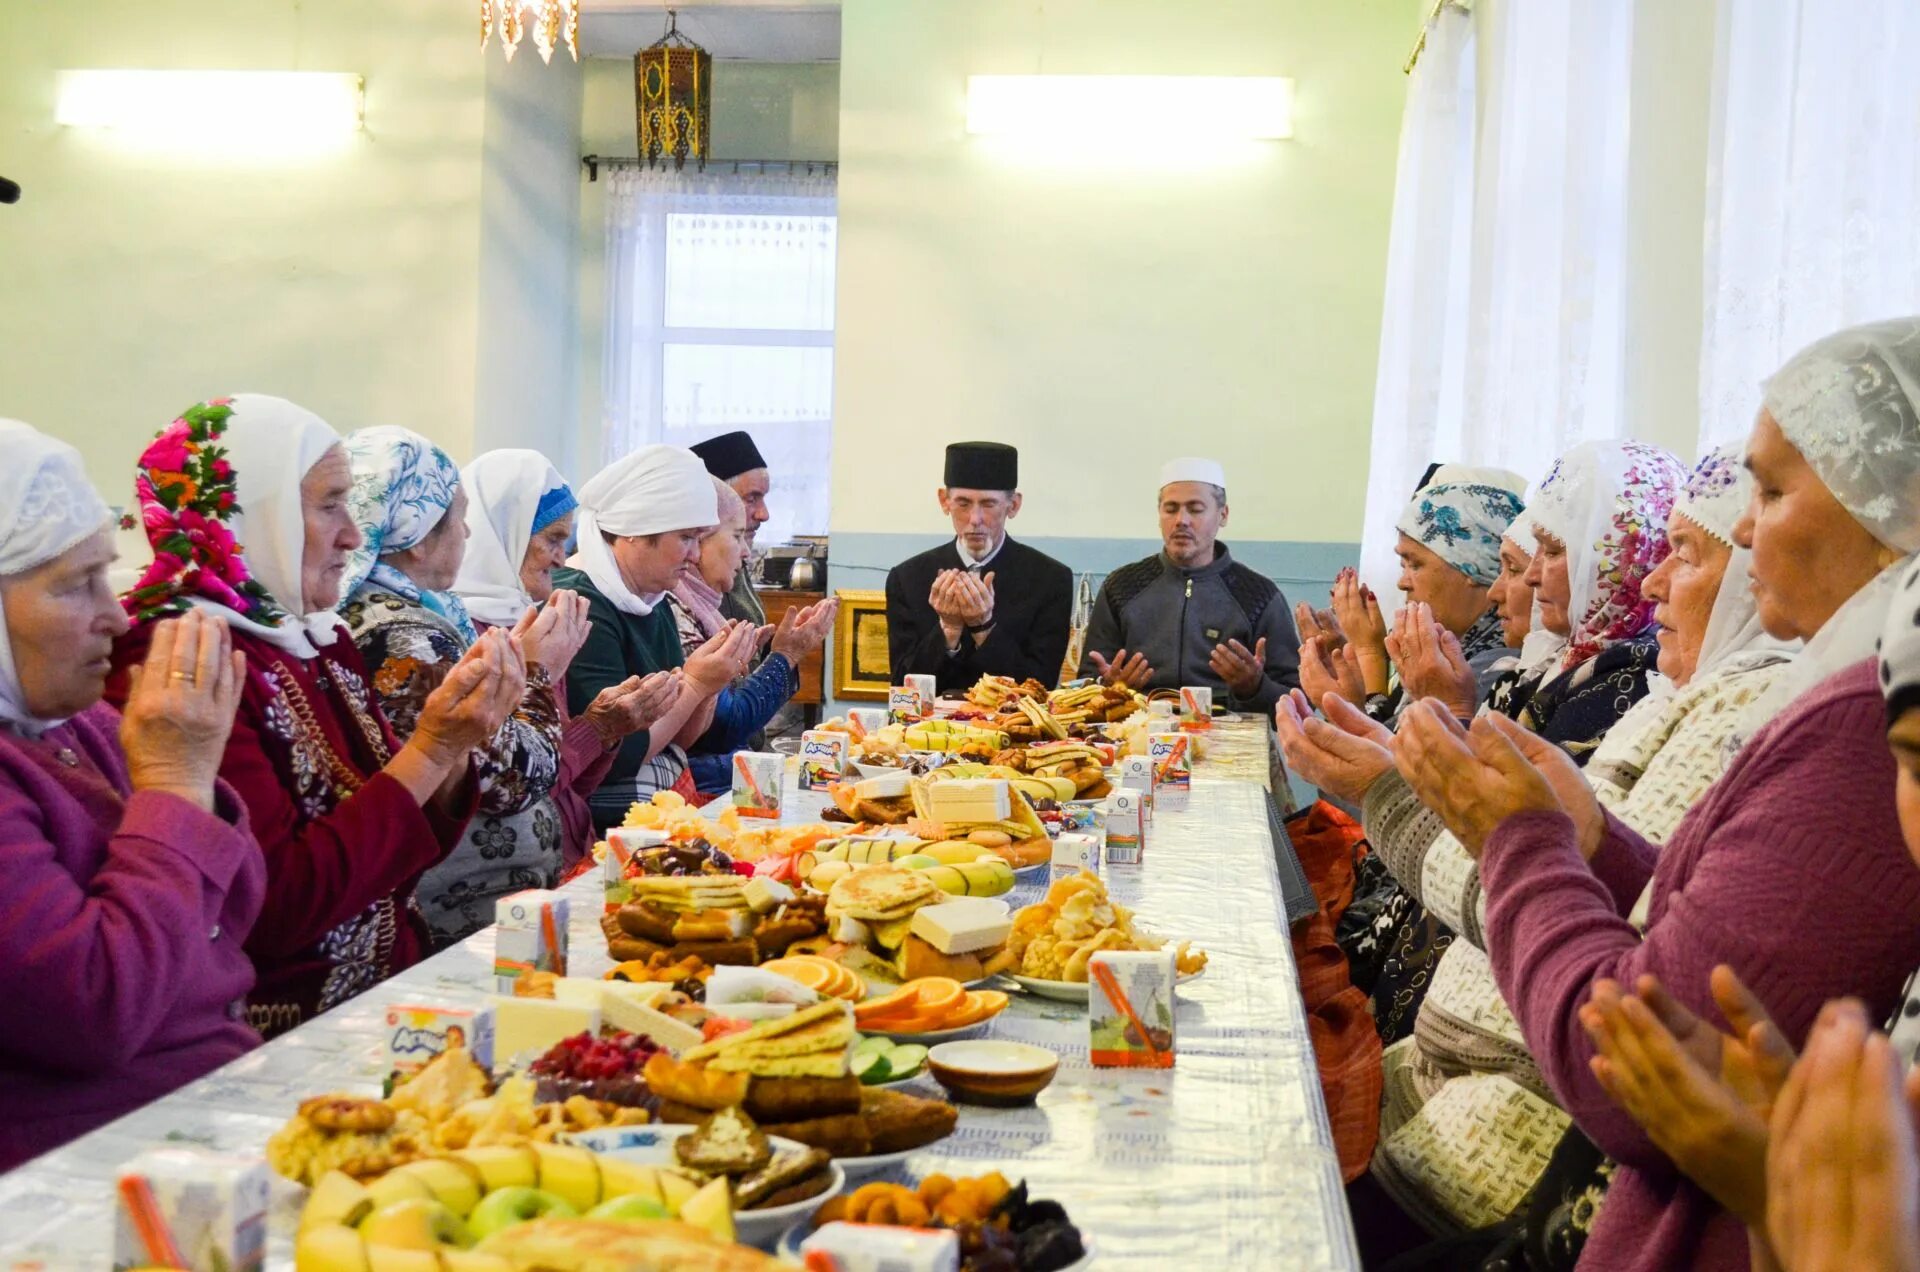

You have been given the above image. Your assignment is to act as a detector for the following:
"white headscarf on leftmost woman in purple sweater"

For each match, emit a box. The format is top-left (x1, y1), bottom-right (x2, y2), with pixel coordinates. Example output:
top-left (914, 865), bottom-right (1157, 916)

top-left (0, 419), bottom-right (113, 738)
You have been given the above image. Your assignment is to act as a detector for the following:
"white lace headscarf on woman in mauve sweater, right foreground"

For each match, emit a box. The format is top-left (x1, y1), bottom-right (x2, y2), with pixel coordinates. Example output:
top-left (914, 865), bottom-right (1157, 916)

top-left (1738, 317), bottom-right (1920, 742)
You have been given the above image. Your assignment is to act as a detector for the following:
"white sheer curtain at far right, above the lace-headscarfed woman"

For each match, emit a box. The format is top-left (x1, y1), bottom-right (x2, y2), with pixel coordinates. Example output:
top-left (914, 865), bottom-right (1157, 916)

top-left (1699, 0), bottom-right (1920, 450)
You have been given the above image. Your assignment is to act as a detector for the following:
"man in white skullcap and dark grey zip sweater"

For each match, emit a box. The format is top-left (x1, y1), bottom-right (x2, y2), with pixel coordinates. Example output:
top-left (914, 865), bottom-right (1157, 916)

top-left (1081, 459), bottom-right (1300, 713)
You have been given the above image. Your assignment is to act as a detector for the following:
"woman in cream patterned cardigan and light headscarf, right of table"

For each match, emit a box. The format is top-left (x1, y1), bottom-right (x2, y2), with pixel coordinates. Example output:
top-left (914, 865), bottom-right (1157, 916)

top-left (1373, 448), bottom-right (1789, 1266)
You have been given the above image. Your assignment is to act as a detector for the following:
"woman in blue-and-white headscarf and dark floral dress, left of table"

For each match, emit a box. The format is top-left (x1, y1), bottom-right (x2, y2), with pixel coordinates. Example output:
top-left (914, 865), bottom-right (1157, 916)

top-left (340, 427), bottom-right (679, 947)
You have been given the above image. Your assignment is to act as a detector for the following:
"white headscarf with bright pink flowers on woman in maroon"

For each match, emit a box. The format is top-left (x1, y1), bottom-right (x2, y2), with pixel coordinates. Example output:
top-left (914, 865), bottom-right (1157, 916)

top-left (121, 394), bottom-right (342, 657)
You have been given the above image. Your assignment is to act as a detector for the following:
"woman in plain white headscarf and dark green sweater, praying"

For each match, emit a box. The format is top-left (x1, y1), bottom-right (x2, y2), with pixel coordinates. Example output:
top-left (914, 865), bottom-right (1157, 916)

top-left (553, 446), bottom-right (760, 828)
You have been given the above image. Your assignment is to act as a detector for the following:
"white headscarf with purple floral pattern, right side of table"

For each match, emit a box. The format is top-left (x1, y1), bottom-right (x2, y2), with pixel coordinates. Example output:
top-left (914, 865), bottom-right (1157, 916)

top-left (1526, 442), bottom-right (1686, 671)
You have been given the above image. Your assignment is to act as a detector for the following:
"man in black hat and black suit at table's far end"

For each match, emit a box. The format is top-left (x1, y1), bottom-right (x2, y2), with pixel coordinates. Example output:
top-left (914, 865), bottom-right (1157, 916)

top-left (887, 442), bottom-right (1073, 694)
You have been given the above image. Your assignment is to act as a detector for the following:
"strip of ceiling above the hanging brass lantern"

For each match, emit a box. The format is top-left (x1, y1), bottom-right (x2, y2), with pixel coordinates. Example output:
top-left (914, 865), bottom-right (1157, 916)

top-left (580, 0), bottom-right (839, 61)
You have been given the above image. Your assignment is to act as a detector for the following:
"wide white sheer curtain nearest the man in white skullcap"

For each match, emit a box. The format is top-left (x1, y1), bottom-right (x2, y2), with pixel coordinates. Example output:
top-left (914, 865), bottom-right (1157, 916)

top-left (1361, 0), bottom-right (1638, 598)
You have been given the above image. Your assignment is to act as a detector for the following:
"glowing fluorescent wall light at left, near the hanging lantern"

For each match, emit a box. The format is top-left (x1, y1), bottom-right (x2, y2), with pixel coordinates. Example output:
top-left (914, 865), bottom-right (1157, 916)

top-left (54, 71), bottom-right (361, 150)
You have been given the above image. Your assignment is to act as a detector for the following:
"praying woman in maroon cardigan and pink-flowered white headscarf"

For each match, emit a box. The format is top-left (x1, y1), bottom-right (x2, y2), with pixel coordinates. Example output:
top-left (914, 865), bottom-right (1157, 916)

top-left (109, 403), bottom-right (526, 1036)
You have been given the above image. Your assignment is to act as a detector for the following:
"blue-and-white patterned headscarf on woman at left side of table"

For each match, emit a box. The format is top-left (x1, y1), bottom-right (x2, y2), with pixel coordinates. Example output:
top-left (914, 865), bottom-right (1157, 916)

top-left (342, 425), bottom-right (478, 644)
